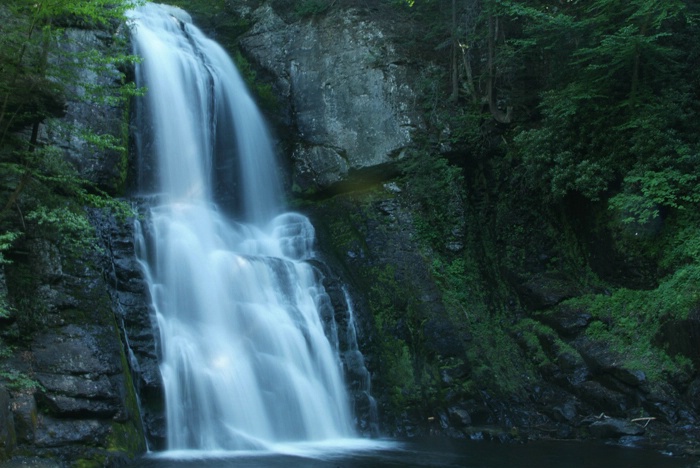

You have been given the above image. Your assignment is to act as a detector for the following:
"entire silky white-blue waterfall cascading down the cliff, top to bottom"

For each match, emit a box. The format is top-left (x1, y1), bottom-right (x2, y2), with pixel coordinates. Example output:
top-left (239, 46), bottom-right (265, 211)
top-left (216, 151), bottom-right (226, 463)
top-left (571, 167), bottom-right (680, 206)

top-left (131, 4), bottom-right (354, 451)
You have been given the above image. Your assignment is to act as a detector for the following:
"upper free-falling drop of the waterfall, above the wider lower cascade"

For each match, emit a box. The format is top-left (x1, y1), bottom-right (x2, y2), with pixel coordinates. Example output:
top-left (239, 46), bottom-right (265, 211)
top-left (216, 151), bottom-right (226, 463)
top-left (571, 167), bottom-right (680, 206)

top-left (131, 3), bottom-right (281, 224)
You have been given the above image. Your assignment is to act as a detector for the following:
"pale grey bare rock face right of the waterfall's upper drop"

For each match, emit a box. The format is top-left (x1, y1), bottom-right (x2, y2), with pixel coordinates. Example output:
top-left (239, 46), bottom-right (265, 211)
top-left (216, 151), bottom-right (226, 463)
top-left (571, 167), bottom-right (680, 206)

top-left (241, 5), bottom-right (423, 191)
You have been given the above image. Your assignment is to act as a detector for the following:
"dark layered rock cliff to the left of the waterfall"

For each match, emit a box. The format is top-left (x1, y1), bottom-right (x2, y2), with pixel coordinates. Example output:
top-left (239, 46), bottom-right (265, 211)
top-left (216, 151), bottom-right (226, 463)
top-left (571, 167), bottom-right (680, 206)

top-left (0, 28), bottom-right (146, 466)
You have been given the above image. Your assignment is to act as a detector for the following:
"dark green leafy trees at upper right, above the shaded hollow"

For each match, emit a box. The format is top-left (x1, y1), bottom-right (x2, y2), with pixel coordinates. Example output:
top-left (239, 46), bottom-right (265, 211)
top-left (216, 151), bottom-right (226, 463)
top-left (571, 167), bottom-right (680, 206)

top-left (400, 0), bottom-right (699, 212)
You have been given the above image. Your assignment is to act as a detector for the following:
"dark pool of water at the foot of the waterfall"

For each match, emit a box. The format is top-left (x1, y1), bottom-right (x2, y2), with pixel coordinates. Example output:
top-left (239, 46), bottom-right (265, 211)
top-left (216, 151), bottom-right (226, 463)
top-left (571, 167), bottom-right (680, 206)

top-left (131, 440), bottom-right (700, 468)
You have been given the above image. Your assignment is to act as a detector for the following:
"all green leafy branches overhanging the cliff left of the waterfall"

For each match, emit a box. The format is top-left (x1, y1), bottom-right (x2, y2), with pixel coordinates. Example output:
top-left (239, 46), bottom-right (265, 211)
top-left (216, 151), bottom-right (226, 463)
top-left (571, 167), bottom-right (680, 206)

top-left (0, 0), bottom-right (137, 380)
